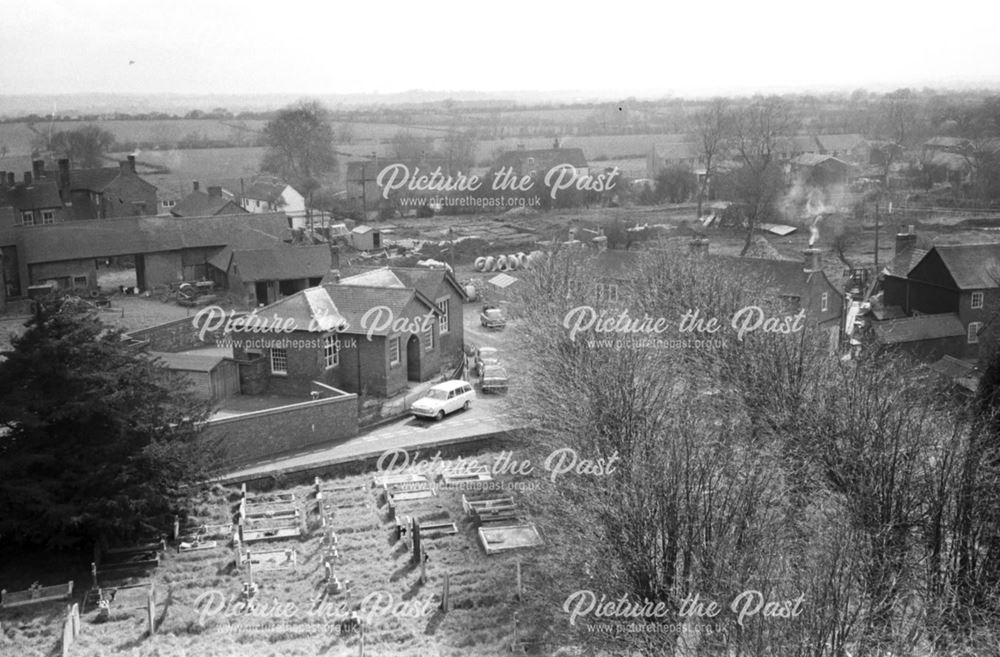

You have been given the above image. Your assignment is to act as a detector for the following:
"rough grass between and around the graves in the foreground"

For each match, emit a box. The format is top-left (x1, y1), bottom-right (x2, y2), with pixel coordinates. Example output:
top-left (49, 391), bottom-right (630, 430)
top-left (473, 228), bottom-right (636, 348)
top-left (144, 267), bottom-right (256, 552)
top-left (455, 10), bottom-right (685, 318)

top-left (0, 455), bottom-right (556, 657)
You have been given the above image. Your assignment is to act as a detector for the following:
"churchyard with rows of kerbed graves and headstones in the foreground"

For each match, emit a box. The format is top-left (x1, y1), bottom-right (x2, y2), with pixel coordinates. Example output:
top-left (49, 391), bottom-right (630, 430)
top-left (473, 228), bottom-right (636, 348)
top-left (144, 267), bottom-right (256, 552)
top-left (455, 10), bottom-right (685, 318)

top-left (0, 448), bottom-right (547, 657)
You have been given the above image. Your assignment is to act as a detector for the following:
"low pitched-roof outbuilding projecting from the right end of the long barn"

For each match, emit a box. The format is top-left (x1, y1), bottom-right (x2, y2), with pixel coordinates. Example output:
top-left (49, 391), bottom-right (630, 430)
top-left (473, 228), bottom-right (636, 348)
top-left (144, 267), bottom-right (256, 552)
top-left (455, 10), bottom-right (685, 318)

top-left (208, 244), bottom-right (332, 308)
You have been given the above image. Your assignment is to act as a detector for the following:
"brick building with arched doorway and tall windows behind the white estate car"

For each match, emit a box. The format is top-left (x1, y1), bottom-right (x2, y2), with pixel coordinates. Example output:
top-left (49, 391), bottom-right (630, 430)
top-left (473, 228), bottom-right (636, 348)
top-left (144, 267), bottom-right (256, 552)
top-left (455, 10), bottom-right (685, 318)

top-left (233, 283), bottom-right (441, 397)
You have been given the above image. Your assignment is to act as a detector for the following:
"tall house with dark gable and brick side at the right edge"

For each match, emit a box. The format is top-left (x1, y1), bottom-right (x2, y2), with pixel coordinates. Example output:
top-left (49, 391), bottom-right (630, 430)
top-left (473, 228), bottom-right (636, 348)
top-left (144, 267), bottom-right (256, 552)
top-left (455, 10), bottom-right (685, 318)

top-left (882, 238), bottom-right (1000, 359)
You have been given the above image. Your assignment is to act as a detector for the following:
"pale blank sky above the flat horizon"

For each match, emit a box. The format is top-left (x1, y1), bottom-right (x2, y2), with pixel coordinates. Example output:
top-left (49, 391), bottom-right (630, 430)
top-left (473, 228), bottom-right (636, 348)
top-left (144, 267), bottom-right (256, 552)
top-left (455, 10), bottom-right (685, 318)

top-left (0, 0), bottom-right (1000, 96)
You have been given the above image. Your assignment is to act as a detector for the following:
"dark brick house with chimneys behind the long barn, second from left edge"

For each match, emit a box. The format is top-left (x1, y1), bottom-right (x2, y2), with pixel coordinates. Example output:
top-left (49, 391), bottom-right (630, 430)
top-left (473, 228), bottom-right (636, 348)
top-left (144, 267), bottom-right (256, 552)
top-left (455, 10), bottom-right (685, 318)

top-left (57, 155), bottom-right (159, 219)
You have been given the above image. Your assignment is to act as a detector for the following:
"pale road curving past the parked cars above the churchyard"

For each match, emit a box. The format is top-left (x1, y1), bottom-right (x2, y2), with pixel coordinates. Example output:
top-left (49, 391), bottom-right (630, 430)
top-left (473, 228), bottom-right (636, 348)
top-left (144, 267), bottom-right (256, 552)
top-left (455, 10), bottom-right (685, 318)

top-left (219, 304), bottom-right (515, 483)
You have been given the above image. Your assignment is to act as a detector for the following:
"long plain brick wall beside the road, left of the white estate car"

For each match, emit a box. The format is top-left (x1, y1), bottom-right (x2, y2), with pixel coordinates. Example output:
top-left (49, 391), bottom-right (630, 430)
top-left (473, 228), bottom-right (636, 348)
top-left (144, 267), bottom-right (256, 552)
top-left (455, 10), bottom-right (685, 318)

top-left (202, 395), bottom-right (358, 467)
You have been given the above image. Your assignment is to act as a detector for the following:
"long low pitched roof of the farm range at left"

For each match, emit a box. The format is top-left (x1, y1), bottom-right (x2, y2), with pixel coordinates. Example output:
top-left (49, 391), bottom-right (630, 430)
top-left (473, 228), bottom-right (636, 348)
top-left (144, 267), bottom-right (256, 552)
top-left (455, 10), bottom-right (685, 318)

top-left (7, 212), bottom-right (291, 264)
